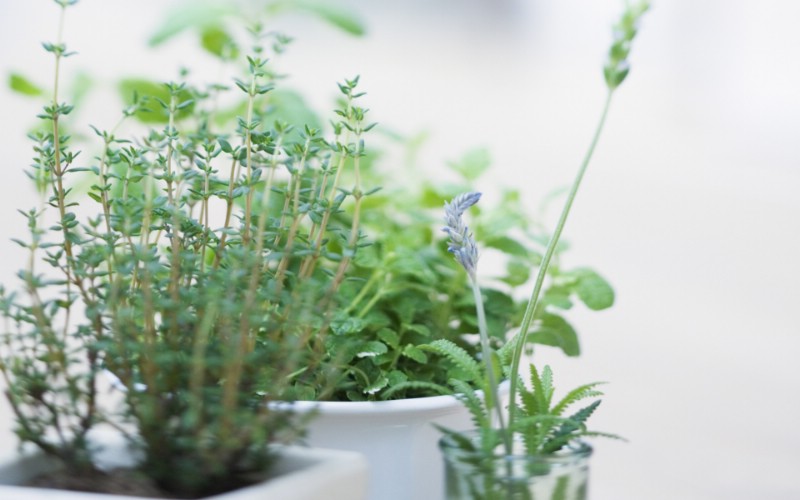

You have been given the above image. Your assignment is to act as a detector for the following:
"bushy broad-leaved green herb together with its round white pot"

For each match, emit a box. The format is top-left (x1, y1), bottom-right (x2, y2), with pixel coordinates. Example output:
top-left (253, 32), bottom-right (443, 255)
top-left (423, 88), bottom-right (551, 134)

top-left (294, 157), bottom-right (614, 499)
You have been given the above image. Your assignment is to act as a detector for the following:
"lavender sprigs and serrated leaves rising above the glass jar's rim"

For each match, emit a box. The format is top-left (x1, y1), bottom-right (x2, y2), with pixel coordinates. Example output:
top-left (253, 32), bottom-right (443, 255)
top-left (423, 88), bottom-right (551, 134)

top-left (436, 0), bottom-right (649, 455)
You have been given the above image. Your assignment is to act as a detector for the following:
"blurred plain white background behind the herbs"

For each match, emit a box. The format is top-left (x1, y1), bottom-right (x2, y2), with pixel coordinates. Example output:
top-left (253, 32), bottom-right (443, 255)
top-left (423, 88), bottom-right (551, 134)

top-left (0, 0), bottom-right (800, 500)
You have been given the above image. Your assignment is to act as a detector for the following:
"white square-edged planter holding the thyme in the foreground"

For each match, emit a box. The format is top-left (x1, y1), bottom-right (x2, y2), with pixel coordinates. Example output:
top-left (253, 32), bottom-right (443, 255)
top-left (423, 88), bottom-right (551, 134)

top-left (0, 430), bottom-right (367, 500)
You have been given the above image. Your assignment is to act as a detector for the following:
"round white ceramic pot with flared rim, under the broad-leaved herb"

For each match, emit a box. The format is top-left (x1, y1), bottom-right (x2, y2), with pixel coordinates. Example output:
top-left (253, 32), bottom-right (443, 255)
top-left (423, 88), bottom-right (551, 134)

top-left (292, 385), bottom-right (508, 500)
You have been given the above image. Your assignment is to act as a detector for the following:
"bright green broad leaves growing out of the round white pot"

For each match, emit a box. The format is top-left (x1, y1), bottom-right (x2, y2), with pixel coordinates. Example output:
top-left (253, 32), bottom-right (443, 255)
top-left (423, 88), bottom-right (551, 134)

top-left (328, 143), bottom-right (614, 400)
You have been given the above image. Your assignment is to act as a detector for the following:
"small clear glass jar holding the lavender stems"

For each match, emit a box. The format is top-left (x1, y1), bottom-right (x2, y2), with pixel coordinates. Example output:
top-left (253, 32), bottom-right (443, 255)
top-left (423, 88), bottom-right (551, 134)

top-left (439, 433), bottom-right (592, 500)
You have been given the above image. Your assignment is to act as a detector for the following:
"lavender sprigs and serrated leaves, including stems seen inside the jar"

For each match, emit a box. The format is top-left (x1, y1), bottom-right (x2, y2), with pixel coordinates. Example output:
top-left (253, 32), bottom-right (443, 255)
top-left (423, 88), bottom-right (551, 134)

top-left (428, 1), bottom-right (649, 498)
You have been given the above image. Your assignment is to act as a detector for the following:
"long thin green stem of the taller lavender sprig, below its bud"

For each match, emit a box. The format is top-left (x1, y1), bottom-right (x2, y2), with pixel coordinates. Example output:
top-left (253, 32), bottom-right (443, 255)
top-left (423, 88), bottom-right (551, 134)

top-left (508, 90), bottom-right (614, 426)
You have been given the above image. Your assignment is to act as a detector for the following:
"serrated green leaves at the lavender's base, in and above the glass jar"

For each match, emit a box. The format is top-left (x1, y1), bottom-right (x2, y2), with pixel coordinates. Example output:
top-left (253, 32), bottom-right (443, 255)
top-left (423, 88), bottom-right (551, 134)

top-left (439, 365), bottom-right (621, 500)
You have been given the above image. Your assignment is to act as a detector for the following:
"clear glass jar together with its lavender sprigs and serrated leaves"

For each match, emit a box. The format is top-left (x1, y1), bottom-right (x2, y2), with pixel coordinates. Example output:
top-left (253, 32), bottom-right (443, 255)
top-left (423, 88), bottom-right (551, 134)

top-left (429, 0), bottom-right (649, 500)
